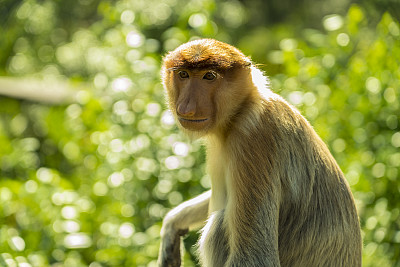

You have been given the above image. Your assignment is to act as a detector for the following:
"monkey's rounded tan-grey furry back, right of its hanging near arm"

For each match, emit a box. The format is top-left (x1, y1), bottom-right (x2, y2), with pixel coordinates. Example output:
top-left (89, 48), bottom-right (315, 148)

top-left (228, 93), bottom-right (362, 266)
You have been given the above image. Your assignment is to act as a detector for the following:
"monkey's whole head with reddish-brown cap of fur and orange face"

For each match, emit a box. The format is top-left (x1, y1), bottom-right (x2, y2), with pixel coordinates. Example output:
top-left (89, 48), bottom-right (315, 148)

top-left (161, 39), bottom-right (254, 134)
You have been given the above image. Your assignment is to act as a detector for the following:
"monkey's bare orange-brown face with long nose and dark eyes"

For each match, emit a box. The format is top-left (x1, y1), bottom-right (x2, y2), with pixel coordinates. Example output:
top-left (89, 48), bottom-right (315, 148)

top-left (167, 69), bottom-right (223, 132)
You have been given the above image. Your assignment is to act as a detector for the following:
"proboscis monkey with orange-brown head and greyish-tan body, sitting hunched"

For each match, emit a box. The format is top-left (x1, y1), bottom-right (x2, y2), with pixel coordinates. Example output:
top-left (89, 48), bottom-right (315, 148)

top-left (159, 39), bottom-right (362, 267)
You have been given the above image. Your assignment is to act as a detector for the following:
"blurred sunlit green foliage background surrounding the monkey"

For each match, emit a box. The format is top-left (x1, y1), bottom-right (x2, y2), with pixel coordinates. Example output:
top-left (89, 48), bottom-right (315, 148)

top-left (0, 0), bottom-right (400, 267)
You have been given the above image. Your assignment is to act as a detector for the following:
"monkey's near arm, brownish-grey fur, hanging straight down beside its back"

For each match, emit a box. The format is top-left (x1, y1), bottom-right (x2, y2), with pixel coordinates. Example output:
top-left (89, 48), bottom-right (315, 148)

top-left (224, 140), bottom-right (282, 267)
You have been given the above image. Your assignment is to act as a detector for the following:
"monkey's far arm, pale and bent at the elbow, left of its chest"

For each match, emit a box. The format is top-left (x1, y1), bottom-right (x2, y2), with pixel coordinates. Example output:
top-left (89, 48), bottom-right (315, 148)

top-left (158, 190), bottom-right (211, 267)
